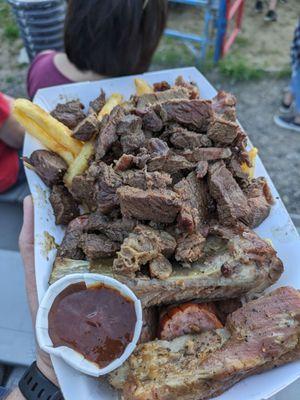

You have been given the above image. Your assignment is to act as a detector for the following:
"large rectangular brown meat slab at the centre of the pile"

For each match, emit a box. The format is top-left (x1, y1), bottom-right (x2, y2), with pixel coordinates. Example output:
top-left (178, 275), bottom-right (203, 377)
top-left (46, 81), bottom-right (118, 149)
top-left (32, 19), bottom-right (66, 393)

top-left (117, 186), bottom-right (180, 224)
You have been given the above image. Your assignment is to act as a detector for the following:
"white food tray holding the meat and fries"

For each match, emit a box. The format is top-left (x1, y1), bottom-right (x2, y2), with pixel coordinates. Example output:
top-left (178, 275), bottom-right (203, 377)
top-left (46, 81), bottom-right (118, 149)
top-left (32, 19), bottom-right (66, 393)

top-left (24, 68), bottom-right (300, 400)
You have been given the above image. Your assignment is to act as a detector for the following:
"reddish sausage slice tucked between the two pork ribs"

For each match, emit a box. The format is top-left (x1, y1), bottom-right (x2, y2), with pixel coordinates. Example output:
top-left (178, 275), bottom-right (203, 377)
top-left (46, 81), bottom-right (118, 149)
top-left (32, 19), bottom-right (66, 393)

top-left (158, 303), bottom-right (223, 340)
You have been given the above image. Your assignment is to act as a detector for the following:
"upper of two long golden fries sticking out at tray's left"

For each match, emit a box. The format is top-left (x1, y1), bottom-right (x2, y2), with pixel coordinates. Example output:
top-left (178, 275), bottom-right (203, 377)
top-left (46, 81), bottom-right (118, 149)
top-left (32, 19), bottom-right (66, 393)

top-left (13, 99), bottom-right (83, 156)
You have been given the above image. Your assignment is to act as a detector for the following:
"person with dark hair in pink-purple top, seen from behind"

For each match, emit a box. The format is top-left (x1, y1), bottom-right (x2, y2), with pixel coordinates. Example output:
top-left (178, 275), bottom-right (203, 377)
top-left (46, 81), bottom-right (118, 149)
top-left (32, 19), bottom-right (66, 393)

top-left (27, 0), bottom-right (167, 99)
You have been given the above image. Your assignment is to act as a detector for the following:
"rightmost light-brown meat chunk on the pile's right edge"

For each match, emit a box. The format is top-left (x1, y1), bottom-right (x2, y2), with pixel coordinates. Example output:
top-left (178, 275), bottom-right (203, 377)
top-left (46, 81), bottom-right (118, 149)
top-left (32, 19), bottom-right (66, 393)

top-left (245, 178), bottom-right (274, 228)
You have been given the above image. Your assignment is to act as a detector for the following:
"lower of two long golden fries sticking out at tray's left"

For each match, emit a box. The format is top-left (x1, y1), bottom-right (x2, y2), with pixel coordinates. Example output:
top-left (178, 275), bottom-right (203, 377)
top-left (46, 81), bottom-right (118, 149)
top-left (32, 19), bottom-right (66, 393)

top-left (14, 109), bottom-right (74, 165)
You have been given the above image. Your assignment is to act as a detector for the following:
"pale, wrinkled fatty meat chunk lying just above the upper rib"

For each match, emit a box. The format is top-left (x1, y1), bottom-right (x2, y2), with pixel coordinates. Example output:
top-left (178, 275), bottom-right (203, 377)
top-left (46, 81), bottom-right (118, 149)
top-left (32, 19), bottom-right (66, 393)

top-left (113, 225), bottom-right (176, 277)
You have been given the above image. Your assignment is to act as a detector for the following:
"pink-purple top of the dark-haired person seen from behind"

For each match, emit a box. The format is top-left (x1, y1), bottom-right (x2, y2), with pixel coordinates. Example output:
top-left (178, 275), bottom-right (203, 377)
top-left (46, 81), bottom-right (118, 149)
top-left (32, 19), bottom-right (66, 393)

top-left (27, 50), bottom-right (73, 99)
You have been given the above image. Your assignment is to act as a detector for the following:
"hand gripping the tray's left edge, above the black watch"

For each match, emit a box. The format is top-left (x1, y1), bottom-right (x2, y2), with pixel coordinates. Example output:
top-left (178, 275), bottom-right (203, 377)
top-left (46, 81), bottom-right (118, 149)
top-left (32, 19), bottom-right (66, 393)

top-left (19, 196), bottom-right (58, 386)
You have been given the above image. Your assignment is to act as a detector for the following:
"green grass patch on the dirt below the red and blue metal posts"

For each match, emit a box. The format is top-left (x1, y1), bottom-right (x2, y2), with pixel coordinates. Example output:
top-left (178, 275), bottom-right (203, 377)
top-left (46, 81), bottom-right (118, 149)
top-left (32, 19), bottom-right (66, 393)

top-left (218, 54), bottom-right (265, 81)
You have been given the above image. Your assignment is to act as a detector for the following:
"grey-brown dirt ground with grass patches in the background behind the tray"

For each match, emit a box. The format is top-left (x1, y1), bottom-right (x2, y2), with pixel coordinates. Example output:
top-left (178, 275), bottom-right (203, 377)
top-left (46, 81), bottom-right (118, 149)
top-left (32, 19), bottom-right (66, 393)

top-left (0, 0), bottom-right (300, 227)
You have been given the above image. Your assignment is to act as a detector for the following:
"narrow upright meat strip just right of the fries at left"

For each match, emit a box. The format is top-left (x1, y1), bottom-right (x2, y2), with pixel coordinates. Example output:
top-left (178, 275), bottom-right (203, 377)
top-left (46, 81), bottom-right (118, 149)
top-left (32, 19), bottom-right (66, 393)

top-left (95, 106), bottom-right (124, 161)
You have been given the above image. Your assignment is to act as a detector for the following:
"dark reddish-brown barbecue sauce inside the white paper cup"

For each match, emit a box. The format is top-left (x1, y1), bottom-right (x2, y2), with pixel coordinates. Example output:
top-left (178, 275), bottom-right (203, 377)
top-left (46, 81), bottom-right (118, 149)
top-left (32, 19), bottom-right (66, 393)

top-left (48, 282), bottom-right (137, 368)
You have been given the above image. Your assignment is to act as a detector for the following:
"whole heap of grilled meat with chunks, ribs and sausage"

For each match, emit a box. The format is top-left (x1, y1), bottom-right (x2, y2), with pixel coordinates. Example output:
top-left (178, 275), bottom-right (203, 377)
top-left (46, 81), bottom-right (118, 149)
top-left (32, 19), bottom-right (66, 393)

top-left (28, 77), bottom-right (300, 400)
